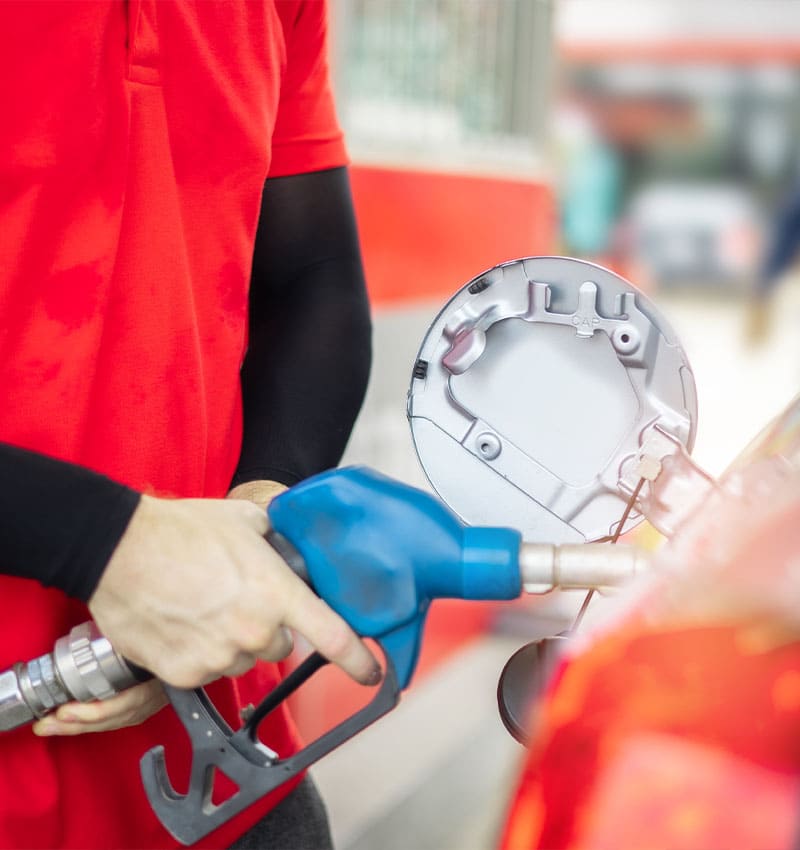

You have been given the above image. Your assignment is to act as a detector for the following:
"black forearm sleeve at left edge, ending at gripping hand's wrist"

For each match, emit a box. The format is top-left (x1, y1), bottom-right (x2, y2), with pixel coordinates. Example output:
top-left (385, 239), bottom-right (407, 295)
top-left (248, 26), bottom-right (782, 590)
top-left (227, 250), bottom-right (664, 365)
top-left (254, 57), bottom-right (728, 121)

top-left (0, 443), bottom-right (140, 602)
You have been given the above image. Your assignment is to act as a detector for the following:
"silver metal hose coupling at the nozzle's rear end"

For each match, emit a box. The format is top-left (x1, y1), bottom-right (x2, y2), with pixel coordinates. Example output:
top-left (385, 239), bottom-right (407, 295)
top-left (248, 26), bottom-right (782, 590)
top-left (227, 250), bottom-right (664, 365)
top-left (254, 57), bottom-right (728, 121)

top-left (0, 622), bottom-right (142, 731)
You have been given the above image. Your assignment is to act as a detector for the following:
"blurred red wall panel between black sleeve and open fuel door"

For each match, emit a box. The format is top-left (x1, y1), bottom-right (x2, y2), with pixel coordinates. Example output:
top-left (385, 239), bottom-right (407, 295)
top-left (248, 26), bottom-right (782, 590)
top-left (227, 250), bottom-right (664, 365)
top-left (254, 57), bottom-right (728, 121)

top-left (351, 165), bottom-right (556, 306)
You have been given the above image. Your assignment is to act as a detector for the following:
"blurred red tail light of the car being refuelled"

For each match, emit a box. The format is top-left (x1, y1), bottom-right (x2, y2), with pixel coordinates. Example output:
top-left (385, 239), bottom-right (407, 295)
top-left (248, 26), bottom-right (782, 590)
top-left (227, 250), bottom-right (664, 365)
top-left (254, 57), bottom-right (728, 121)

top-left (502, 623), bottom-right (800, 850)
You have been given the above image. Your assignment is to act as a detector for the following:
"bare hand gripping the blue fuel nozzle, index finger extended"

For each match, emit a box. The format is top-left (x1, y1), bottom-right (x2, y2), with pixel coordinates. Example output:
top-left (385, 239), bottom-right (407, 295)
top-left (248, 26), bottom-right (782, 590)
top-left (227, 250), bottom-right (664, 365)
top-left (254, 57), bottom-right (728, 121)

top-left (89, 496), bottom-right (380, 688)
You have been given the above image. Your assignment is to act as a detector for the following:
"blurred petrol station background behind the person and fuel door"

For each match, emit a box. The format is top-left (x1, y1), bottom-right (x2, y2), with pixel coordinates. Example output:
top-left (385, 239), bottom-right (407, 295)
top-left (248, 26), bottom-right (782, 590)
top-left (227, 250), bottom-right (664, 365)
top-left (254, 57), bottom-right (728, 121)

top-left (296, 0), bottom-right (800, 850)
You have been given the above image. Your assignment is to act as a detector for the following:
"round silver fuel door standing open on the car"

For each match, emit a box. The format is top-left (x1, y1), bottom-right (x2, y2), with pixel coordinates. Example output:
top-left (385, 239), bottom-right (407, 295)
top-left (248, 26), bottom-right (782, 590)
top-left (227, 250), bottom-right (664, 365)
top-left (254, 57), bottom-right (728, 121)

top-left (408, 257), bottom-right (697, 543)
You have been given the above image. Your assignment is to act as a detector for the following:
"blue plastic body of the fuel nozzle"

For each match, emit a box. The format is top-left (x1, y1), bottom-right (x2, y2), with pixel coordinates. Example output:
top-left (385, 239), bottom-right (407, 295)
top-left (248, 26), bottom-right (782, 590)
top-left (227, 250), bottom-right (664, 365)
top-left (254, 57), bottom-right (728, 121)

top-left (268, 467), bottom-right (522, 688)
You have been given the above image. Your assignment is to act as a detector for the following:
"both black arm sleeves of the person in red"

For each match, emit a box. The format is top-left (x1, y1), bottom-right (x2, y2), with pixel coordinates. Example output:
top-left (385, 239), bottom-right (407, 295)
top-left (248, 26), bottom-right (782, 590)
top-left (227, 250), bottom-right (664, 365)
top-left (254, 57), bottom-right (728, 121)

top-left (0, 169), bottom-right (371, 601)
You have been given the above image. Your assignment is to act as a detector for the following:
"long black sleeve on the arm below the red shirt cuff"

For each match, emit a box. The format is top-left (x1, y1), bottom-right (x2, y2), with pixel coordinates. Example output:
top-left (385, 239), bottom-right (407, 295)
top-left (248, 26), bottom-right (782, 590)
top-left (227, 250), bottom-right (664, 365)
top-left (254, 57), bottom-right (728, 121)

top-left (233, 168), bottom-right (371, 485)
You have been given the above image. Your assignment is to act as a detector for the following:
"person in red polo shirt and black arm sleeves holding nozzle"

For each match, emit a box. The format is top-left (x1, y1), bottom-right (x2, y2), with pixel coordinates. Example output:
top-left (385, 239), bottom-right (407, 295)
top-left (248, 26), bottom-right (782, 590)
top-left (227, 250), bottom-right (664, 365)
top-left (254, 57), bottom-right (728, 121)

top-left (0, 0), bottom-right (380, 848)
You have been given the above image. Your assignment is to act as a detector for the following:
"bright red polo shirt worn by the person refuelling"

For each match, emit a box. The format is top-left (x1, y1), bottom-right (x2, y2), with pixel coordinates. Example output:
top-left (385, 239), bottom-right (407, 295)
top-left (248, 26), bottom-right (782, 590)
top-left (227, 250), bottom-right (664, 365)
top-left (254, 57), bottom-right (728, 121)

top-left (0, 0), bottom-right (345, 848)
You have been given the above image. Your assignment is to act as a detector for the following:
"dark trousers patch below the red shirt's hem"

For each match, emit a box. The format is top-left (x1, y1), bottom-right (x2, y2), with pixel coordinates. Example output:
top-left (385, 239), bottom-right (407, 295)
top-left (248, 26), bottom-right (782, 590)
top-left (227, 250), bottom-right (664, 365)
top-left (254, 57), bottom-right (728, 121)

top-left (230, 776), bottom-right (333, 850)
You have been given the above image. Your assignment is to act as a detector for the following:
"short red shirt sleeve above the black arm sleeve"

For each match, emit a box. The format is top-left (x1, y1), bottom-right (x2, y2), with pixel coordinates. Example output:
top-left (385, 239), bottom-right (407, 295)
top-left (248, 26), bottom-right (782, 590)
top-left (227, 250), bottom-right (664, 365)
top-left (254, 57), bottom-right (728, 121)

top-left (269, 0), bottom-right (348, 177)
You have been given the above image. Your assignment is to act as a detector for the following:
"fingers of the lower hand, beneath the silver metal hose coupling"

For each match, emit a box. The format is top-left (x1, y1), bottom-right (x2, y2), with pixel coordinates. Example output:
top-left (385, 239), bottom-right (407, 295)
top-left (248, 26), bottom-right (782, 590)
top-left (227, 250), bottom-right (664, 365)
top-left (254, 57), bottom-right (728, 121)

top-left (33, 680), bottom-right (167, 736)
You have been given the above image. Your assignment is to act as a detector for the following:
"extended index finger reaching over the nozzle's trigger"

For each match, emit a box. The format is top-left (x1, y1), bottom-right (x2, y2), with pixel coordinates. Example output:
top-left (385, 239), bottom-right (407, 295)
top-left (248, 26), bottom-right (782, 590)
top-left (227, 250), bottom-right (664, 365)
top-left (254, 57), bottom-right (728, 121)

top-left (284, 579), bottom-right (383, 685)
